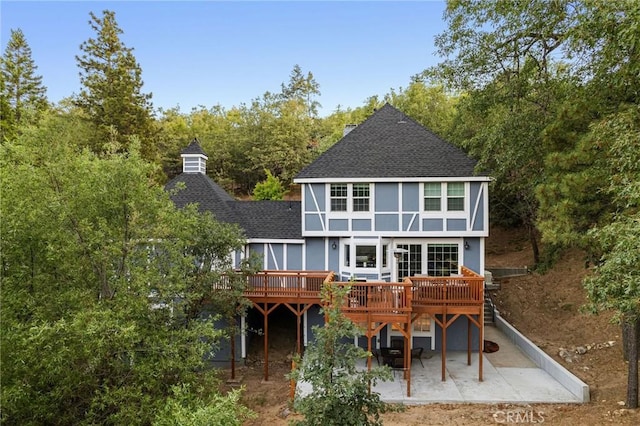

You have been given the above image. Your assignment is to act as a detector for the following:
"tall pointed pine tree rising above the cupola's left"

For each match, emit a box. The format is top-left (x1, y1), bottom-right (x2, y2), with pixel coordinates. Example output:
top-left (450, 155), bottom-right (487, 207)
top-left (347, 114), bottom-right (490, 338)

top-left (75, 10), bottom-right (154, 159)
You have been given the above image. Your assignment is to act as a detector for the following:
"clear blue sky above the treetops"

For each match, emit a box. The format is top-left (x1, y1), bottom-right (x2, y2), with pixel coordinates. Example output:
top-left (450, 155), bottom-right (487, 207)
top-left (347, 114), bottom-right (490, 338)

top-left (0, 0), bottom-right (445, 115)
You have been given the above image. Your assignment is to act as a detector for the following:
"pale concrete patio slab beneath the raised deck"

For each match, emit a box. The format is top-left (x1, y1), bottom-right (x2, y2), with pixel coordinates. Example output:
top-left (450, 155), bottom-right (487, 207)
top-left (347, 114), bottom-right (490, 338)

top-left (298, 326), bottom-right (588, 405)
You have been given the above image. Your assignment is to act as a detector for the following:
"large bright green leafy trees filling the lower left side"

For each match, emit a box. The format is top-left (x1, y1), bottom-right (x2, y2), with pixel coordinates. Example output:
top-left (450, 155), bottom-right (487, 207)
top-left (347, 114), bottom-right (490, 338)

top-left (0, 121), bottom-right (254, 424)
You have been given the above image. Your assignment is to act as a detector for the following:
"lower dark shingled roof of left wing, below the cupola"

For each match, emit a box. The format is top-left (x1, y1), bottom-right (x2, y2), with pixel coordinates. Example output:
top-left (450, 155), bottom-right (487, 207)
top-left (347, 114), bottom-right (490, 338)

top-left (165, 173), bottom-right (302, 239)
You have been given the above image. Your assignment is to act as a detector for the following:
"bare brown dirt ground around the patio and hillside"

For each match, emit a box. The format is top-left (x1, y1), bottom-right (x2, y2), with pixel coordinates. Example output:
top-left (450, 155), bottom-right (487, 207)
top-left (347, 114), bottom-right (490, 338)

top-left (226, 229), bottom-right (640, 426)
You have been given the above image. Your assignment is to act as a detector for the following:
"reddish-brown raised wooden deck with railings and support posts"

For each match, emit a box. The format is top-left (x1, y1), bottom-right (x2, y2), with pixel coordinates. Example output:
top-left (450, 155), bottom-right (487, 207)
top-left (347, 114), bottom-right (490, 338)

top-left (231, 267), bottom-right (484, 395)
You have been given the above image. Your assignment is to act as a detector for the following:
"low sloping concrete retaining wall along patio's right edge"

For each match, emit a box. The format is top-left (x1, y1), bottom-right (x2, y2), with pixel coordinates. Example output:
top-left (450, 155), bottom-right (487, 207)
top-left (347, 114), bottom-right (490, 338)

top-left (495, 310), bottom-right (590, 403)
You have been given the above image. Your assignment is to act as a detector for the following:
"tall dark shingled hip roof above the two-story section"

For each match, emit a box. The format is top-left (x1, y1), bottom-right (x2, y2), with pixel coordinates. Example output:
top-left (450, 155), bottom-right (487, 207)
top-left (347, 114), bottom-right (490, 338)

top-left (295, 104), bottom-right (476, 180)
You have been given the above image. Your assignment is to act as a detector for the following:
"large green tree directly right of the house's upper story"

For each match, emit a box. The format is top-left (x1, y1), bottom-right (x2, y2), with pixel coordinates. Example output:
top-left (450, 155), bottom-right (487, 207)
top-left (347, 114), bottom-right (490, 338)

top-left (425, 0), bottom-right (640, 263)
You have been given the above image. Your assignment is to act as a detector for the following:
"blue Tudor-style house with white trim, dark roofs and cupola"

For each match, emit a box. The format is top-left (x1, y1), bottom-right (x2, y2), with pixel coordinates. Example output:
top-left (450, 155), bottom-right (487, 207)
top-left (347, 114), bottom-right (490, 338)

top-left (167, 104), bottom-right (489, 386)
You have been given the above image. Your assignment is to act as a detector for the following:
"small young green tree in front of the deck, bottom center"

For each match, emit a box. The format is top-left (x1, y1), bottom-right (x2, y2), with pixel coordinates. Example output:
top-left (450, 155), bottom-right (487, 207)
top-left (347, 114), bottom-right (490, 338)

top-left (290, 283), bottom-right (391, 426)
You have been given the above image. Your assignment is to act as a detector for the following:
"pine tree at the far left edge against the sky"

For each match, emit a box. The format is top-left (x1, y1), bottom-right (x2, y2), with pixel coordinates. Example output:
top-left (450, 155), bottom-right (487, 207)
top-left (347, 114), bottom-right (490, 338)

top-left (0, 29), bottom-right (47, 135)
